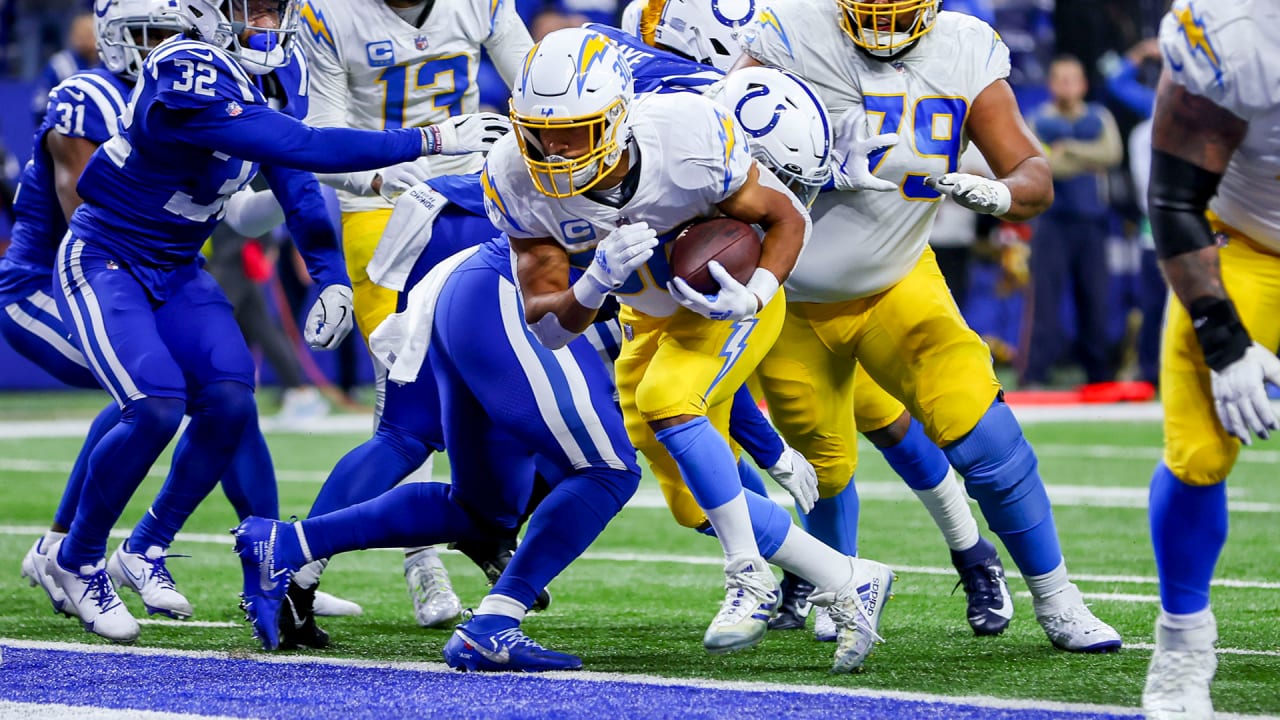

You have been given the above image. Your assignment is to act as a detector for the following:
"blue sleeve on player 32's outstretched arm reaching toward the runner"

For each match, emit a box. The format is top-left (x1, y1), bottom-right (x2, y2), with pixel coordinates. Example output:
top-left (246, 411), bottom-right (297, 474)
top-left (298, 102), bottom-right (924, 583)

top-left (160, 99), bottom-right (422, 173)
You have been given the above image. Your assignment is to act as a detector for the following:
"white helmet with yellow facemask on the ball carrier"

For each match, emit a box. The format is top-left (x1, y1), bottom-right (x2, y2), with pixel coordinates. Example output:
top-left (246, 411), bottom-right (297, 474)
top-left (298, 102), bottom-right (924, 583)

top-left (511, 28), bottom-right (632, 197)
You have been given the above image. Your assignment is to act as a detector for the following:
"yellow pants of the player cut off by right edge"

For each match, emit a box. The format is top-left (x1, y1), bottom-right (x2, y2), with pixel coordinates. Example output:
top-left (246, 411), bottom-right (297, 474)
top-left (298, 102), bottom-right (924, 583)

top-left (1160, 214), bottom-right (1280, 486)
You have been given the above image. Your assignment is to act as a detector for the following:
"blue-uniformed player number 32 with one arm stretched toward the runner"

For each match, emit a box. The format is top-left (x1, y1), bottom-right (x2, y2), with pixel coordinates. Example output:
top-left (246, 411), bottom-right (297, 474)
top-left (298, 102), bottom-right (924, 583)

top-left (49, 0), bottom-right (506, 642)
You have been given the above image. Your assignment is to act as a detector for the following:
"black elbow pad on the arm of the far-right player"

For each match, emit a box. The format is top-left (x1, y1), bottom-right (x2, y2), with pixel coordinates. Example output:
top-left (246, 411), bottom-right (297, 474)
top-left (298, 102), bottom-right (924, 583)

top-left (1147, 150), bottom-right (1222, 260)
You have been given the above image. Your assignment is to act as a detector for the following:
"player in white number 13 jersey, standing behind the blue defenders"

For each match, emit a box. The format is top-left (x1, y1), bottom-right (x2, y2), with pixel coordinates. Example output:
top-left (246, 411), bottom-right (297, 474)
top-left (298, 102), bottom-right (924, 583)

top-left (300, 0), bottom-right (532, 628)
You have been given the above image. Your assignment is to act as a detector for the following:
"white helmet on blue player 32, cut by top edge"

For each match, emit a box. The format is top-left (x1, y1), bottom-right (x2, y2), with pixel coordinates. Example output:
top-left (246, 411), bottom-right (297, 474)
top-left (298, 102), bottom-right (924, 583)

top-left (169, 0), bottom-right (298, 74)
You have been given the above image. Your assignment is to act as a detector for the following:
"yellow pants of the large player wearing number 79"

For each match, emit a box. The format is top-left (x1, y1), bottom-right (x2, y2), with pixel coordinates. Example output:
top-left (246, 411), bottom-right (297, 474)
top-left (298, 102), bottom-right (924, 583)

top-left (758, 247), bottom-right (1000, 497)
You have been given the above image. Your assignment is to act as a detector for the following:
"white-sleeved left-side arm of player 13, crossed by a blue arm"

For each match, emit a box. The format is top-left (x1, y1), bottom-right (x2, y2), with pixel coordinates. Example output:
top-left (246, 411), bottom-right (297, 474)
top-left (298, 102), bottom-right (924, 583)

top-left (298, 3), bottom-right (376, 195)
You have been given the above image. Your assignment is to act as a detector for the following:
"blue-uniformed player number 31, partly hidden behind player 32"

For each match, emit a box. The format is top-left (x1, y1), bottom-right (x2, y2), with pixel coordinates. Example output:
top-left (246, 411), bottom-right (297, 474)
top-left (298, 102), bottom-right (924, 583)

top-left (8, 0), bottom-right (293, 619)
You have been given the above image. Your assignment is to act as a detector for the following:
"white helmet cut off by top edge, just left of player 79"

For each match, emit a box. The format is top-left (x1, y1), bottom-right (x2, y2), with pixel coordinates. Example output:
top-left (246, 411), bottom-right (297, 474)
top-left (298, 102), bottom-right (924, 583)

top-left (640, 0), bottom-right (755, 72)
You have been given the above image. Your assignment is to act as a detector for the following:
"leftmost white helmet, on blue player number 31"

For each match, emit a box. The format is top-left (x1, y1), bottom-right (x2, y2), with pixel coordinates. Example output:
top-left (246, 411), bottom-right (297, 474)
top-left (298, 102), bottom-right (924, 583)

top-left (93, 0), bottom-right (191, 79)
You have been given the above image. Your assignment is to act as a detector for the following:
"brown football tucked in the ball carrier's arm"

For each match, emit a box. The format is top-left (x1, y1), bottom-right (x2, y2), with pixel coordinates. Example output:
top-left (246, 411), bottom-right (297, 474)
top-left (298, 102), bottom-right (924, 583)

top-left (671, 218), bottom-right (760, 295)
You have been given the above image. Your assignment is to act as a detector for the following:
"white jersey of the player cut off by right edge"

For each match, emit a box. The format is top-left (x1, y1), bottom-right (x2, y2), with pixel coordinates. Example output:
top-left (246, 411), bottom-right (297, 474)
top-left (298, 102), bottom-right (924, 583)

top-left (1160, 0), bottom-right (1280, 252)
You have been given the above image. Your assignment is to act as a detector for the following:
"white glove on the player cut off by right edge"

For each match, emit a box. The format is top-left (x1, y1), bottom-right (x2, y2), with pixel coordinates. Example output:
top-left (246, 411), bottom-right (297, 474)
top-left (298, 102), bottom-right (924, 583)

top-left (1210, 342), bottom-right (1280, 445)
